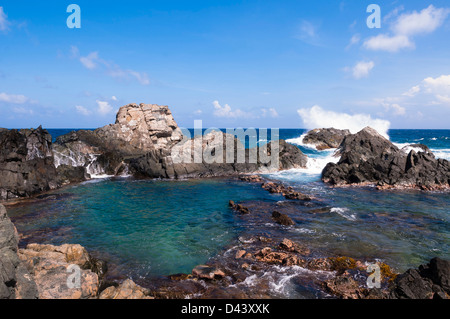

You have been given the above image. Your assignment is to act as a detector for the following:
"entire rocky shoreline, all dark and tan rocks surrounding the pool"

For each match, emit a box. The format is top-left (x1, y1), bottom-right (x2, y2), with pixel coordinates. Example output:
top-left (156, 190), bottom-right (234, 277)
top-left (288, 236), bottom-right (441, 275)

top-left (0, 104), bottom-right (450, 299)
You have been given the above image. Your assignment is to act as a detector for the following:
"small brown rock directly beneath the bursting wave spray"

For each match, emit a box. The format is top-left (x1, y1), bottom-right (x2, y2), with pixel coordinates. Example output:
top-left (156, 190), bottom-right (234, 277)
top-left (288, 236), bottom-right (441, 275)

top-left (303, 128), bottom-right (350, 150)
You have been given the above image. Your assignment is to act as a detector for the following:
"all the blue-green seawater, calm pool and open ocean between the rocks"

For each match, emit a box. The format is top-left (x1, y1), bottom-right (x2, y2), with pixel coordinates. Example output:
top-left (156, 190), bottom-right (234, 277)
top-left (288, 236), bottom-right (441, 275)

top-left (8, 129), bottom-right (450, 298)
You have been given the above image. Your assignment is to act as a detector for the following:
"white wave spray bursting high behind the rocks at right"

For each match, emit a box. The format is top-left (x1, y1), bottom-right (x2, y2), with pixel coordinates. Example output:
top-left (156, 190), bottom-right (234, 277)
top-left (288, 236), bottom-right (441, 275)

top-left (297, 105), bottom-right (390, 137)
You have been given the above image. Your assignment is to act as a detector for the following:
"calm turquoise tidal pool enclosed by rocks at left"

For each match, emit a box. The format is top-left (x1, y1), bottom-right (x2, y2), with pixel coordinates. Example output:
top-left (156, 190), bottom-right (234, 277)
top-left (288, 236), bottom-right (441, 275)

top-left (8, 178), bottom-right (272, 277)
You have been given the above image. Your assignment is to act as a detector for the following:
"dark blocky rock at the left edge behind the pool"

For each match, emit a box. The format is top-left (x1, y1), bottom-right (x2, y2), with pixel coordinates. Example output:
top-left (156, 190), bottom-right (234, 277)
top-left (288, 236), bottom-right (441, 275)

top-left (0, 127), bottom-right (59, 200)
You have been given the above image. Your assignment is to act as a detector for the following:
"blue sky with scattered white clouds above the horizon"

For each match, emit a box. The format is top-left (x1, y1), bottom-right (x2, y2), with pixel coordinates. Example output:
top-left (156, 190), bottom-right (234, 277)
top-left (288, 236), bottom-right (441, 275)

top-left (0, 0), bottom-right (450, 129)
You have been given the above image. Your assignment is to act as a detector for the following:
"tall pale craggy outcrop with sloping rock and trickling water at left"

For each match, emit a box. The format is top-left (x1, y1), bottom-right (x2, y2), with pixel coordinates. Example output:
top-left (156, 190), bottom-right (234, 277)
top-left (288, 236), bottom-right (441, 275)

top-left (54, 104), bottom-right (182, 182)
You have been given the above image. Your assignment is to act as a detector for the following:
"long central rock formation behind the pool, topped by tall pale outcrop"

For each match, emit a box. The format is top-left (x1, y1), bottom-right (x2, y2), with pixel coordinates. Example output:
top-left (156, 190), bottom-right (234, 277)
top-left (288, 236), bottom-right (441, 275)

top-left (53, 104), bottom-right (307, 182)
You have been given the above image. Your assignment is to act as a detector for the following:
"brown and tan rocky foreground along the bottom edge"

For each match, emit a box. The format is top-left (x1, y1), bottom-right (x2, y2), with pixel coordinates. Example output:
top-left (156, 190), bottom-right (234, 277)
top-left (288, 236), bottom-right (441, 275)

top-left (0, 203), bottom-right (450, 299)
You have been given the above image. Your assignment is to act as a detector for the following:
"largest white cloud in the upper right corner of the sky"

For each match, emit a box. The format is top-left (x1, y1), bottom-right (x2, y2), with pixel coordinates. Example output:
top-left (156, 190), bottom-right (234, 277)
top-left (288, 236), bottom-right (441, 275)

top-left (364, 5), bottom-right (450, 52)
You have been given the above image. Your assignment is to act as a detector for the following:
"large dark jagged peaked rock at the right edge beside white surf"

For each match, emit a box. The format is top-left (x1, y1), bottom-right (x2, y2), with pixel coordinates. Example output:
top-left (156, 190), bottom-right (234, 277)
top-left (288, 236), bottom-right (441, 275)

top-left (322, 127), bottom-right (450, 189)
